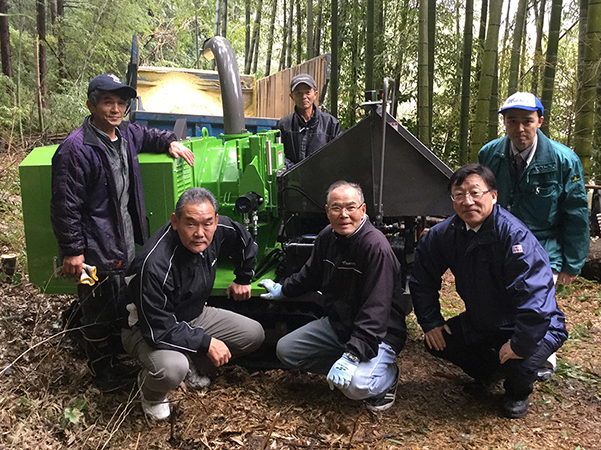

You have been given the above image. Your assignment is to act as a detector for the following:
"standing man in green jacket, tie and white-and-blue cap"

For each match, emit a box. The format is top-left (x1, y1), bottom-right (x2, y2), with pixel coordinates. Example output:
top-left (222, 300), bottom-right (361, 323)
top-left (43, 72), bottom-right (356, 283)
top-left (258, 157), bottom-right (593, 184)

top-left (478, 92), bottom-right (589, 379)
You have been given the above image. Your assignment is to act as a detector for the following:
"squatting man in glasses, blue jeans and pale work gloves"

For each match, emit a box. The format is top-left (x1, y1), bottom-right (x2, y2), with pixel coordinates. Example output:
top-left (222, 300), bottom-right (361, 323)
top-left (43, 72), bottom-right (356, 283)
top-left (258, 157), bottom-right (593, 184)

top-left (255, 181), bottom-right (406, 412)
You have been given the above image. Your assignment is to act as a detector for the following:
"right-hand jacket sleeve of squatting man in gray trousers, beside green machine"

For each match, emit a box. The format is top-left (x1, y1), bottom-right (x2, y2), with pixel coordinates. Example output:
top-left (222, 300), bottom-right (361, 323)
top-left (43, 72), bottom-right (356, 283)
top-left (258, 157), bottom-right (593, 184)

top-left (217, 216), bottom-right (259, 285)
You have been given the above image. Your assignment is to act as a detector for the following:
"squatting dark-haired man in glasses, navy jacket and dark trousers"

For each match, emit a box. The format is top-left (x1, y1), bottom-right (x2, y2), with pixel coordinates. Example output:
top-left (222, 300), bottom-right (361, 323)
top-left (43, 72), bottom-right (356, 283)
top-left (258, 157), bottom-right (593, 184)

top-left (409, 164), bottom-right (567, 418)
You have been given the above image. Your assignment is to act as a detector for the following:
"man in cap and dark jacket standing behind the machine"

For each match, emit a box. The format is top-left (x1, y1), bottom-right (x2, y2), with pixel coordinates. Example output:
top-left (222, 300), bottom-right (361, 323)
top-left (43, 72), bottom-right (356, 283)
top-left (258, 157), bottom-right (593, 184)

top-left (276, 73), bottom-right (342, 168)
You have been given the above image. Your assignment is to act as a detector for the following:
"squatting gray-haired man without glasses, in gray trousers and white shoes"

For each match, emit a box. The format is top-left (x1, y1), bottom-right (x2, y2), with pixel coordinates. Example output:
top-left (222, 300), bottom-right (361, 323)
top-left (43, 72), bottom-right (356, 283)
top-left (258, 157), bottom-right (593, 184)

top-left (121, 188), bottom-right (265, 420)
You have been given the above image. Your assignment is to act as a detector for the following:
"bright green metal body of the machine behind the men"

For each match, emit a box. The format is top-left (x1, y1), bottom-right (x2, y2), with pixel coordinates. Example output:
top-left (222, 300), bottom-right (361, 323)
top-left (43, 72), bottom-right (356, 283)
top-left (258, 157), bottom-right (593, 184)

top-left (19, 131), bottom-right (284, 295)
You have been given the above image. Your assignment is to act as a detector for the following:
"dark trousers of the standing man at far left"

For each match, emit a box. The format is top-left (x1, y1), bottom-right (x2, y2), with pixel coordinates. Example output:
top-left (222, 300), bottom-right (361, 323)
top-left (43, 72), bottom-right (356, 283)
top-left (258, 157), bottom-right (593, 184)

top-left (77, 275), bottom-right (125, 376)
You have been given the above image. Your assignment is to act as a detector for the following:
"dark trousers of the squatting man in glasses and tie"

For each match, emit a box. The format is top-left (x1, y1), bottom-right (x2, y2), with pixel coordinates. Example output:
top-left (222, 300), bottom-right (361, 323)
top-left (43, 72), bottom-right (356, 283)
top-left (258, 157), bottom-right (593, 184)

top-left (426, 315), bottom-right (553, 400)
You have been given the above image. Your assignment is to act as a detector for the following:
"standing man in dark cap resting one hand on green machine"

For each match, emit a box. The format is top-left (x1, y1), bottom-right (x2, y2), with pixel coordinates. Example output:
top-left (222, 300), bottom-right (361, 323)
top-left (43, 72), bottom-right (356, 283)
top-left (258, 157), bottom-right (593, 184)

top-left (50, 74), bottom-right (194, 391)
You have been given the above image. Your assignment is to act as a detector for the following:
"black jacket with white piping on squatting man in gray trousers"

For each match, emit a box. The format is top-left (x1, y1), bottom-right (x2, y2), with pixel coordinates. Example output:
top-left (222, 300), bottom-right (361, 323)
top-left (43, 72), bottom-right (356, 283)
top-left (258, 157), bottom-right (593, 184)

top-left (127, 216), bottom-right (258, 353)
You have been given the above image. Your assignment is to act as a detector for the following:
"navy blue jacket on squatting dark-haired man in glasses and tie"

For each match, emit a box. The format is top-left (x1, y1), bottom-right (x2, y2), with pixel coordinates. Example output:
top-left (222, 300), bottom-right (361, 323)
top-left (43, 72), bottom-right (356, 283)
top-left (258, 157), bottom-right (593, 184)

top-left (409, 205), bottom-right (567, 357)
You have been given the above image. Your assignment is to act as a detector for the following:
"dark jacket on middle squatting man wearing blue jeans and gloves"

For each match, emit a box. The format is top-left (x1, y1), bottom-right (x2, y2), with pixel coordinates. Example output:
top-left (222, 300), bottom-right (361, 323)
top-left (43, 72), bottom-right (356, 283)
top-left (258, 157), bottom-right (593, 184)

top-left (282, 216), bottom-right (406, 361)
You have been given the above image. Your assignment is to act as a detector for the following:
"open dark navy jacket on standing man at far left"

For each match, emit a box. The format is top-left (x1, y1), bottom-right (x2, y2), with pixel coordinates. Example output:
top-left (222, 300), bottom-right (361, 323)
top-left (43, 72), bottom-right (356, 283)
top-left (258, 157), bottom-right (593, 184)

top-left (50, 117), bottom-right (177, 275)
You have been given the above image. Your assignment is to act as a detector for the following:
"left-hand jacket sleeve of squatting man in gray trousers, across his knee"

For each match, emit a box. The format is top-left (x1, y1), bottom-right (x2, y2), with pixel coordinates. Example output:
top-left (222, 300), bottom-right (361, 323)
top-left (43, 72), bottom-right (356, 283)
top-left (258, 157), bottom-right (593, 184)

top-left (131, 262), bottom-right (211, 353)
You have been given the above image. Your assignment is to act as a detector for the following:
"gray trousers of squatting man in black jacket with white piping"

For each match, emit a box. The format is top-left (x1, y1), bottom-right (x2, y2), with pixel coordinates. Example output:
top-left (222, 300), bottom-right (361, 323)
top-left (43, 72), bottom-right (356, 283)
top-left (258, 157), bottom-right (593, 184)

top-left (121, 306), bottom-right (265, 401)
